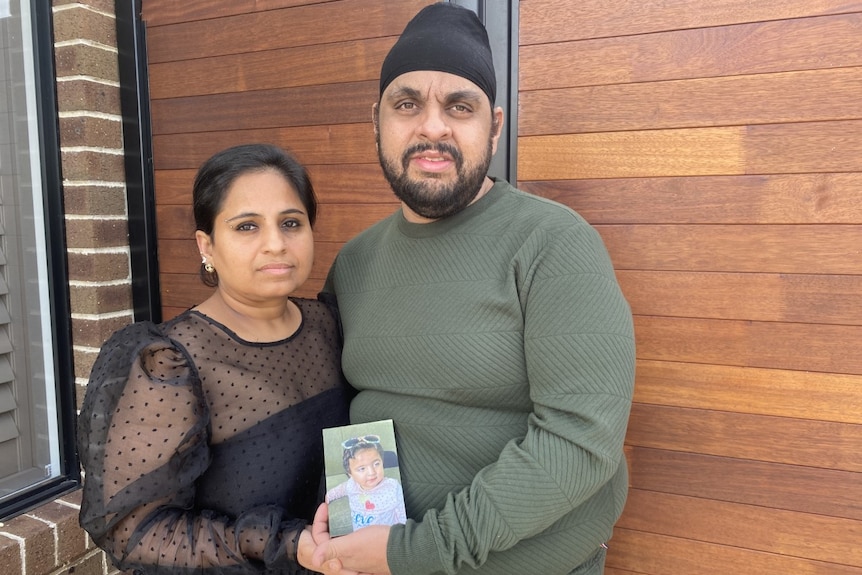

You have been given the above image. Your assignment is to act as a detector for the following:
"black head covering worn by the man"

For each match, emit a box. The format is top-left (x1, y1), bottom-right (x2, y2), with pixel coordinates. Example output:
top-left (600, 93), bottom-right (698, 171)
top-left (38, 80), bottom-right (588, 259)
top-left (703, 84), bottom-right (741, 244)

top-left (380, 2), bottom-right (497, 106)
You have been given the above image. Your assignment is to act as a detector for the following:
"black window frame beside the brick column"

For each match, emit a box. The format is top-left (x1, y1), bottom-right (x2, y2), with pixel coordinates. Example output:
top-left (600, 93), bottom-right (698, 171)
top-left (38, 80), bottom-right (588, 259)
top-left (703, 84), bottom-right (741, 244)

top-left (0, 0), bottom-right (81, 520)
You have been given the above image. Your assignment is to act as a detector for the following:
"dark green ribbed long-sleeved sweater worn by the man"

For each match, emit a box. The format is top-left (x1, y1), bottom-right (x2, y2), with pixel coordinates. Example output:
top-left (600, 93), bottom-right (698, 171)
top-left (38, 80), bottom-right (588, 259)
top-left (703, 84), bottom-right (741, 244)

top-left (324, 180), bottom-right (635, 575)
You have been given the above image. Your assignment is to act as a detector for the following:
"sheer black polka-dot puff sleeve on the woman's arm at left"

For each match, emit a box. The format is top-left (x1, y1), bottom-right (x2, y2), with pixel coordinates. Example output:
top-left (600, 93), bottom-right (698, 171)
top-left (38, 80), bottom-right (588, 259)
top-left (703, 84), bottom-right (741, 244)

top-left (78, 323), bottom-right (305, 575)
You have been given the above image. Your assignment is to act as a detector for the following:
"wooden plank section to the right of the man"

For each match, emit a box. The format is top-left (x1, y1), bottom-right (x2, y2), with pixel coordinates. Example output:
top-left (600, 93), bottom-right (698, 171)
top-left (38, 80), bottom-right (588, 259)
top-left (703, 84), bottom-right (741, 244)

top-left (518, 0), bottom-right (862, 575)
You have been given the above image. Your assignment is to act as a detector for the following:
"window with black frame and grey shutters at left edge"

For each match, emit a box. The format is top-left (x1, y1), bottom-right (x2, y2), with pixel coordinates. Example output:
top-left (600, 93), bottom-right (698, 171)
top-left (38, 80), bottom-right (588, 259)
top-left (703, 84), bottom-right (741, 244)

top-left (0, 0), bottom-right (77, 518)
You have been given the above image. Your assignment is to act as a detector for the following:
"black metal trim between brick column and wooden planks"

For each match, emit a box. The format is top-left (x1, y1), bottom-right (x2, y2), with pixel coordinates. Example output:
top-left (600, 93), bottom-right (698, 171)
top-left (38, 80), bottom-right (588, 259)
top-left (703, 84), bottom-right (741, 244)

top-left (114, 0), bottom-right (162, 323)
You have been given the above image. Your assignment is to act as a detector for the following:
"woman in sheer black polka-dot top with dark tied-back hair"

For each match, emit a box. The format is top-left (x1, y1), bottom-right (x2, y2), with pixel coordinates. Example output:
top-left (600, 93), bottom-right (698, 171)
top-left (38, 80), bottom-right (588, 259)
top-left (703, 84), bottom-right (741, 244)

top-left (78, 144), bottom-right (349, 575)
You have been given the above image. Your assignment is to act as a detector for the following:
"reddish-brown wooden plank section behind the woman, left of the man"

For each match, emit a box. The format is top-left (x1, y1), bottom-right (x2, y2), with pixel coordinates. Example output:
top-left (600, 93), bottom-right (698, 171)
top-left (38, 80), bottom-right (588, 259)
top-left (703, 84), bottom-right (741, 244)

top-left (142, 0), bottom-right (438, 319)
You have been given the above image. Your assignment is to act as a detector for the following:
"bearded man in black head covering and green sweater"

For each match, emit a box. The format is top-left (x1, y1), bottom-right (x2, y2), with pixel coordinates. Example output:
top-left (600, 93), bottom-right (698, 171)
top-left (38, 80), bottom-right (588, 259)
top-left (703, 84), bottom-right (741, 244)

top-left (315, 3), bottom-right (634, 575)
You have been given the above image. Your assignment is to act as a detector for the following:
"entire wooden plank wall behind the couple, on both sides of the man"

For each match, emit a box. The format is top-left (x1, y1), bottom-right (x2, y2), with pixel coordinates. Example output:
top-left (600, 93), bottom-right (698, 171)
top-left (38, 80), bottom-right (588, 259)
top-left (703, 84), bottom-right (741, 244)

top-left (138, 0), bottom-right (862, 575)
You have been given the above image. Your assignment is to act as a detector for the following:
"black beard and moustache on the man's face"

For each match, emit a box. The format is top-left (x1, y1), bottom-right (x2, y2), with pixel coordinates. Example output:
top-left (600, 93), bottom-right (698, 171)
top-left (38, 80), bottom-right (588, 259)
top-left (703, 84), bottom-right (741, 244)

top-left (377, 139), bottom-right (493, 220)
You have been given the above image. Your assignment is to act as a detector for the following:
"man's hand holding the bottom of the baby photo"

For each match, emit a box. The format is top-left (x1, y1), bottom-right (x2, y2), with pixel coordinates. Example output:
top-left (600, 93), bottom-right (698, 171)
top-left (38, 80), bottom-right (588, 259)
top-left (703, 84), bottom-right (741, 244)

top-left (311, 503), bottom-right (389, 575)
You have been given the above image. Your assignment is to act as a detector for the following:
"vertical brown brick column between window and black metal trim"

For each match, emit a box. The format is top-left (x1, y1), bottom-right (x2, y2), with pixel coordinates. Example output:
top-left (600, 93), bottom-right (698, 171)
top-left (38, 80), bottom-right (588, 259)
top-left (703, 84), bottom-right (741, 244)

top-left (54, 0), bottom-right (132, 398)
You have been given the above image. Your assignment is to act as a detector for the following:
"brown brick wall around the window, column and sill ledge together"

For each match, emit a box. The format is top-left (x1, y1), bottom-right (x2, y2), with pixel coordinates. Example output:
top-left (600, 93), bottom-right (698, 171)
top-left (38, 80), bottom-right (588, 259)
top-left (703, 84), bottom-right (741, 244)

top-left (0, 0), bottom-right (133, 575)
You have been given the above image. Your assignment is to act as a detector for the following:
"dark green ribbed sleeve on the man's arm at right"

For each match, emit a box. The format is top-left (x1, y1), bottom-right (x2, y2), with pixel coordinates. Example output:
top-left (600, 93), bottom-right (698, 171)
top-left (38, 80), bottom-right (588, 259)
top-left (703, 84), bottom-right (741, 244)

top-left (387, 223), bottom-right (635, 575)
